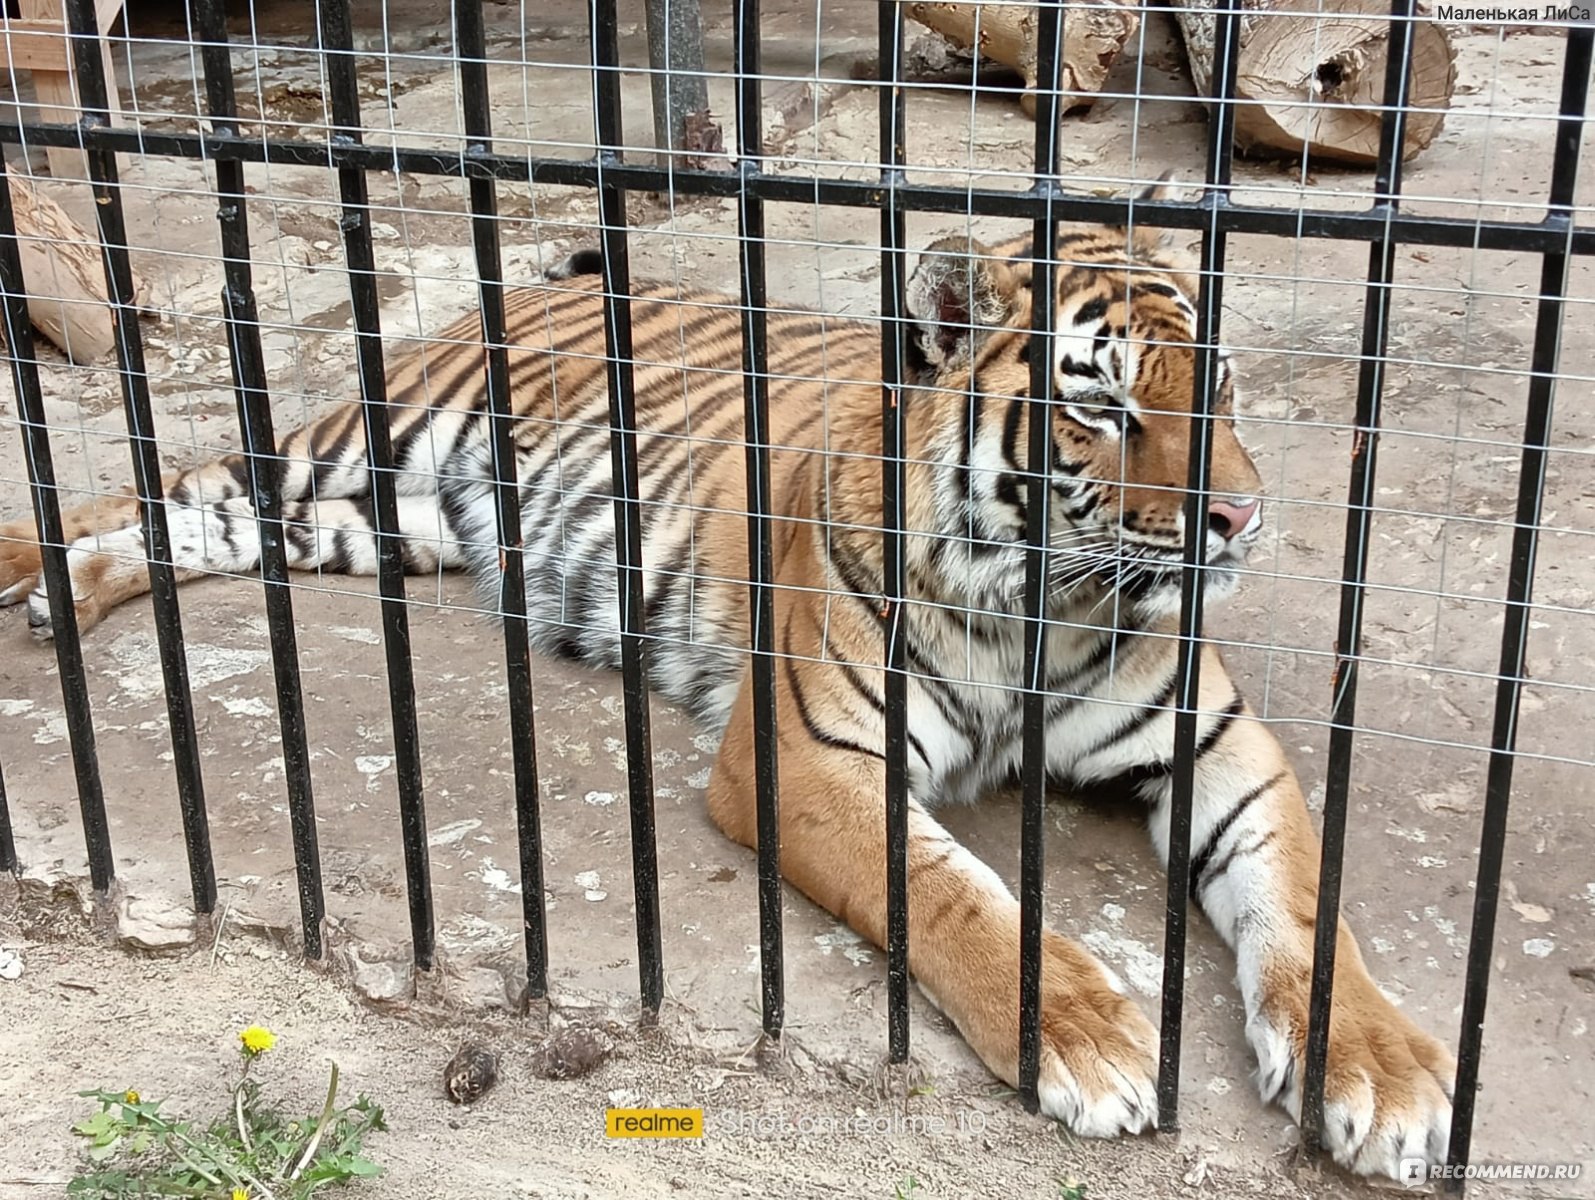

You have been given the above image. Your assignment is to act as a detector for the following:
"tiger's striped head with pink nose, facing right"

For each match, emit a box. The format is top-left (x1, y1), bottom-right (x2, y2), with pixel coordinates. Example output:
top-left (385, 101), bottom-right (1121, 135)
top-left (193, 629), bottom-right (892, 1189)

top-left (908, 230), bottom-right (1262, 621)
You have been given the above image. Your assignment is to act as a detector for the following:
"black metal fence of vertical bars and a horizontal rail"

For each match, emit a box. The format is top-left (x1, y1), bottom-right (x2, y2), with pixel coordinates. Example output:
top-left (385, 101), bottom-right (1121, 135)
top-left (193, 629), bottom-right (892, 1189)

top-left (0, 0), bottom-right (1595, 1187)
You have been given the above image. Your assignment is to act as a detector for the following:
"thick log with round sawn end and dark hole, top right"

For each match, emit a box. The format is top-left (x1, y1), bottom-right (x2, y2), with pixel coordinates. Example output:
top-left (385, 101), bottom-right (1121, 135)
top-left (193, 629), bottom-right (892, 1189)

top-left (1172, 0), bottom-right (1456, 163)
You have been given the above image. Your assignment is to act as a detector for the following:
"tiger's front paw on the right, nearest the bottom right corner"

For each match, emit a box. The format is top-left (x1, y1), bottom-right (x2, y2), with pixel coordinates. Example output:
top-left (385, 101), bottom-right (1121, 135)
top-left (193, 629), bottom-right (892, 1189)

top-left (1247, 972), bottom-right (1456, 1179)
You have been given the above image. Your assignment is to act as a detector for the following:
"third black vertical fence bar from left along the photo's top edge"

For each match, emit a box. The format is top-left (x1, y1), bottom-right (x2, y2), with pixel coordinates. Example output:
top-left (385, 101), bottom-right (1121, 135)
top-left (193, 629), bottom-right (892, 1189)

top-left (317, 0), bottom-right (434, 970)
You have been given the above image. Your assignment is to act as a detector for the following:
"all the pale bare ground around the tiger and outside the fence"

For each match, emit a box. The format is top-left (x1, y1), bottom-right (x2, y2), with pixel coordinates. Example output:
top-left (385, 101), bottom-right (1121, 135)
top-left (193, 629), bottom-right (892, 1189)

top-left (0, 0), bottom-right (1595, 1197)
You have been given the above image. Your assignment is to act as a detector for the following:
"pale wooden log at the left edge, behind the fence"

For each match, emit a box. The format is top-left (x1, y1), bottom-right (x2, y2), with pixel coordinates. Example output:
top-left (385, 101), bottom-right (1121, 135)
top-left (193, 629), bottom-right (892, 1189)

top-left (6, 172), bottom-right (145, 362)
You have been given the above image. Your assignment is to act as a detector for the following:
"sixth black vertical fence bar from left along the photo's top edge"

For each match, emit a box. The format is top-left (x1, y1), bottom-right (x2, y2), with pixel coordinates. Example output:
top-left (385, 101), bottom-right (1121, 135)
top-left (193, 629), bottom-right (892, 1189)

top-left (734, 0), bottom-right (786, 1034)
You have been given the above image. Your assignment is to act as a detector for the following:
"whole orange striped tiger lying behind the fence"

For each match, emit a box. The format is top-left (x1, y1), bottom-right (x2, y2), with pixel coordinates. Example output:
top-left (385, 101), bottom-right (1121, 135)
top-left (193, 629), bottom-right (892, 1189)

top-left (0, 209), bottom-right (1455, 1178)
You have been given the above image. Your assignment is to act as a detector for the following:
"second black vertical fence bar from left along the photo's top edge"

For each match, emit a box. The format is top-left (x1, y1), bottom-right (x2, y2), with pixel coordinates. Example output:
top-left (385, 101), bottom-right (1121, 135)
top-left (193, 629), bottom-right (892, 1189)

top-left (193, 0), bottom-right (325, 959)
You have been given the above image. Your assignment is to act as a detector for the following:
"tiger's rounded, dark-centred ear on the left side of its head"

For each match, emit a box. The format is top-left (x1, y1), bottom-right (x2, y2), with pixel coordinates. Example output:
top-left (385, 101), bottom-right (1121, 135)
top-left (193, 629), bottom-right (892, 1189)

top-left (906, 238), bottom-right (1019, 370)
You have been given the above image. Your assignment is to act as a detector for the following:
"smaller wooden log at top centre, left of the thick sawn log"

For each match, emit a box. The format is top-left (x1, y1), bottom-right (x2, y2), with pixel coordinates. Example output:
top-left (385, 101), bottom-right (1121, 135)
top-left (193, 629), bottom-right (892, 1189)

top-left (908, 0), bottom-right (1140, 116)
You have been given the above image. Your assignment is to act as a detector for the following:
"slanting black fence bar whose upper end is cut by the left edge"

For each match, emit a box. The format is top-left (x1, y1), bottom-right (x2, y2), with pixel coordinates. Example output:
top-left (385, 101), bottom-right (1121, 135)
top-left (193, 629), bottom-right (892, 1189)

top-left (0, 155), bottom-right (115, 892)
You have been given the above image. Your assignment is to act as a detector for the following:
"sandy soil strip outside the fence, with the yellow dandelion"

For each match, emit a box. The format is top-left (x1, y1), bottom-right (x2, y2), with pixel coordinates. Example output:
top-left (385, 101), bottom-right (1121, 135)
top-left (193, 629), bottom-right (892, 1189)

top-left (0, 911), bottom-right (1341, 1200)
